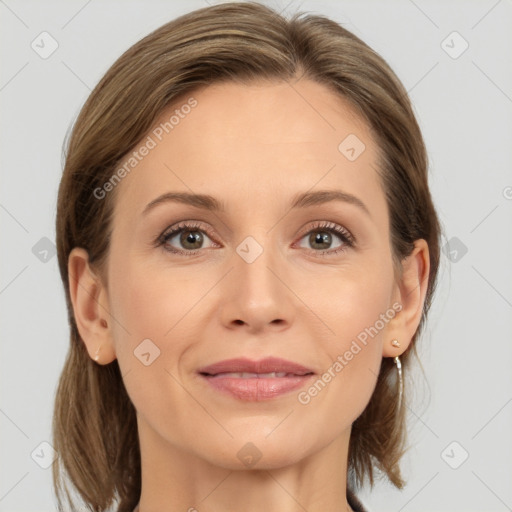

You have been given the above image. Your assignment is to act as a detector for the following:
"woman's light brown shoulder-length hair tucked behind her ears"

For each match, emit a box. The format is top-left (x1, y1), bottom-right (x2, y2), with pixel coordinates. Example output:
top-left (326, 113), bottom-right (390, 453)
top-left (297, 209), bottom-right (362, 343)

top-left (52, 2), bottom-right (441, 512)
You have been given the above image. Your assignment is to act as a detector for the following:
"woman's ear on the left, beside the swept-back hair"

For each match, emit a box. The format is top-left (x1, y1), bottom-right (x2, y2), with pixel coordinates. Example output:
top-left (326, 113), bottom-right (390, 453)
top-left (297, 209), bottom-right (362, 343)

top-left (68, 247), bottom-right (116, 364)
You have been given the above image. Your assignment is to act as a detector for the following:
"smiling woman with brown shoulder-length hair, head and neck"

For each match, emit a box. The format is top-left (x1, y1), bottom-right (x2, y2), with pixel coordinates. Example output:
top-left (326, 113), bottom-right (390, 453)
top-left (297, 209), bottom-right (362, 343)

top-left (53, 3), bottom-right (440, 512)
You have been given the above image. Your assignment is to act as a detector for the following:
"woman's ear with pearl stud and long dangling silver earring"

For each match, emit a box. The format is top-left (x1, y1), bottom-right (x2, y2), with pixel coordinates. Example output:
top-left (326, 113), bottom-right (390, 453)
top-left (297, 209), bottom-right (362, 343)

top-left (382, 239), bottom-right (430, 357)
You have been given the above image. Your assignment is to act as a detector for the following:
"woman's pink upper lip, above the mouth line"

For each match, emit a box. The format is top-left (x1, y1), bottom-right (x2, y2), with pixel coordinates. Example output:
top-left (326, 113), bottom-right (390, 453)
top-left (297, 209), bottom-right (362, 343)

top-left (198, 357), bottom-right (314, 375)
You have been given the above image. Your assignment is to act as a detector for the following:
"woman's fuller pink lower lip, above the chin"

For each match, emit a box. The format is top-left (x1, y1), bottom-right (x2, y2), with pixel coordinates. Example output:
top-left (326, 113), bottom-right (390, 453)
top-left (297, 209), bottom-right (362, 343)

top-left (201, 374), bottom-right (314, 402)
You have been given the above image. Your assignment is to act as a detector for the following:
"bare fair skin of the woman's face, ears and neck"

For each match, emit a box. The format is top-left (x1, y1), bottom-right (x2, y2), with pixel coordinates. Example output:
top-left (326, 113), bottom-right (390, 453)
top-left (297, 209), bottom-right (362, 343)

top-left (69, 80), bottom-right (429, 512)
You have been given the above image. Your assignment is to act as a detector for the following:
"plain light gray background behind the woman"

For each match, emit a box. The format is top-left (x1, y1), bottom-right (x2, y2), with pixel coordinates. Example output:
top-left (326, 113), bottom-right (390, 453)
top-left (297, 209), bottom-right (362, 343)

top-left (0, 0), bottom-right (512, 512)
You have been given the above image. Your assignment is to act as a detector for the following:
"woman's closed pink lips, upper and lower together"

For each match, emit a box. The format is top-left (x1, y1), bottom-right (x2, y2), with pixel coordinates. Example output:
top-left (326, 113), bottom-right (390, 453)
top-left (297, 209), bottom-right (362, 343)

top-left (198, 357), bottom-right (315, 402)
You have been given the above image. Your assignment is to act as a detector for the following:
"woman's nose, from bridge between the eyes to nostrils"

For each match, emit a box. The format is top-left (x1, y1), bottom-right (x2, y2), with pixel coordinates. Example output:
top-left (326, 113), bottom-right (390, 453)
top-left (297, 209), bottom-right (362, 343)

top-left (221, 237), bottom-right (297, 334)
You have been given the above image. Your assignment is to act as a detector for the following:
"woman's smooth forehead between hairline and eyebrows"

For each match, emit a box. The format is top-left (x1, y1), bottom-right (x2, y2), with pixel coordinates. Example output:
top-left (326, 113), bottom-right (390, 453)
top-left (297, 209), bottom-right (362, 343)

top-left (116, 80), bottom-right (382, 219)
